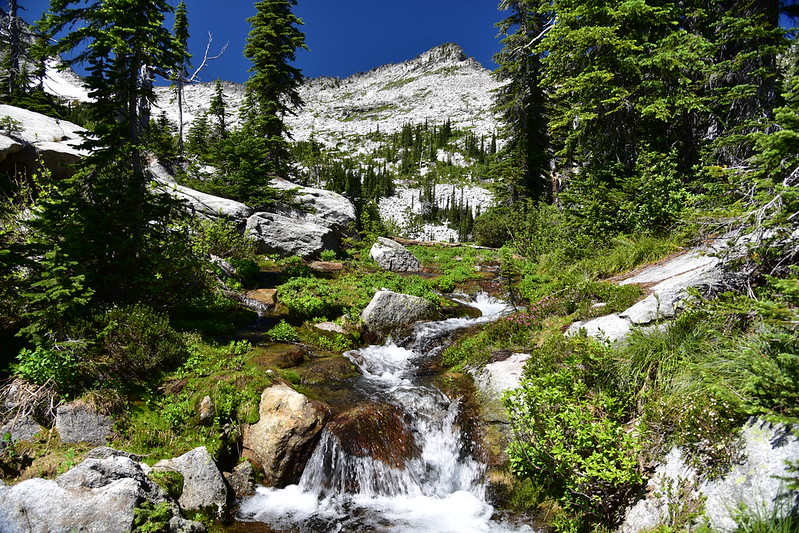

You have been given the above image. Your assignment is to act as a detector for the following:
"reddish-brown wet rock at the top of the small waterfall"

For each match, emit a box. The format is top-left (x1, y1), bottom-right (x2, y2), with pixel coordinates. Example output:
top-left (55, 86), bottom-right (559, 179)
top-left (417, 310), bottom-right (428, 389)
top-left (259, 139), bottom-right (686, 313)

top-left (327, 403), bottom-right (420, 469)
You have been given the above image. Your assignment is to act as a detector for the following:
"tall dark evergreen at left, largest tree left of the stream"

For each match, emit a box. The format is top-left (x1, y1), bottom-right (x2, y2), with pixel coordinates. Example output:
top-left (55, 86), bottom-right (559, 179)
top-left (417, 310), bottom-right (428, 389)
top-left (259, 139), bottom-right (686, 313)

top-left (36, 0), bottom-right (184, 303)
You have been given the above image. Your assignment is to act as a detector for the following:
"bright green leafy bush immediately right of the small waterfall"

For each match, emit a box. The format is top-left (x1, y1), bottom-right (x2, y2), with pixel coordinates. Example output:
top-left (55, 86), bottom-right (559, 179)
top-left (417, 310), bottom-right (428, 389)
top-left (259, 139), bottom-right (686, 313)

top-left (504, 339), bottom-right (641, 523)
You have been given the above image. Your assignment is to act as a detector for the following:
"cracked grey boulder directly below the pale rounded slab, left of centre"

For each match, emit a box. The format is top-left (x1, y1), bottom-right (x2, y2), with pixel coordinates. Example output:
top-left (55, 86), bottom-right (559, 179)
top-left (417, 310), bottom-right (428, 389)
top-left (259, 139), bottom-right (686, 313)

top-left (245, 213), bottom-right (341, 259)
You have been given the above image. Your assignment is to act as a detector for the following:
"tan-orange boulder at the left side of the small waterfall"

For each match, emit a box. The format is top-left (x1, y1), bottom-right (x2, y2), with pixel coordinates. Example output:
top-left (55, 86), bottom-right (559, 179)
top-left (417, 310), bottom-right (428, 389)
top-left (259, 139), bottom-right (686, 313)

top-left (242, 383), bottom-right (328, 487)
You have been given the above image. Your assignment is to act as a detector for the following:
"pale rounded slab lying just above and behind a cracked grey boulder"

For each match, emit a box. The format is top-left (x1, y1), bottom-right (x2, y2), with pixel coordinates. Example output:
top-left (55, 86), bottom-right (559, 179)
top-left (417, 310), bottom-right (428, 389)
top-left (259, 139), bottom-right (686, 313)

top-left (269, 178), bottom-right (357, 236)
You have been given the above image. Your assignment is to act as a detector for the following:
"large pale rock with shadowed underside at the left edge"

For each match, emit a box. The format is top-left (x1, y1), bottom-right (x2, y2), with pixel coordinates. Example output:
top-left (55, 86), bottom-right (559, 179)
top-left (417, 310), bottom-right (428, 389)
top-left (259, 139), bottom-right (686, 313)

top-left (0, 104), bottom-right (87, 179)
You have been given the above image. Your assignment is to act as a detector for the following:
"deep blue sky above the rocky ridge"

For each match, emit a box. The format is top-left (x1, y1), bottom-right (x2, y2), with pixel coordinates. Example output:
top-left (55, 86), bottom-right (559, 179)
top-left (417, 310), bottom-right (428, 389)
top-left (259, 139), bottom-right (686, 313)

top-left (20, 0), bottom-right (510, 82)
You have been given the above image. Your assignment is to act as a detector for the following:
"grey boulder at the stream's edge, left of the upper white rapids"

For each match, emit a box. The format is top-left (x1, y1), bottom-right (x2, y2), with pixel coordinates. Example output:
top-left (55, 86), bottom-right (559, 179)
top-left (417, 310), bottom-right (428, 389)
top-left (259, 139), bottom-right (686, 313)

top-left (361, 289), bottom-right (438, 335)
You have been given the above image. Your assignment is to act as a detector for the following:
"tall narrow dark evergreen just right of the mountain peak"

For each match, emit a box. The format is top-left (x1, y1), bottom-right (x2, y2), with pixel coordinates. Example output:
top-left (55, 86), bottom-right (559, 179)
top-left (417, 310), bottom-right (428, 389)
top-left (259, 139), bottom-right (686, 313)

top-left (495, 0), bottom-right (552, 204)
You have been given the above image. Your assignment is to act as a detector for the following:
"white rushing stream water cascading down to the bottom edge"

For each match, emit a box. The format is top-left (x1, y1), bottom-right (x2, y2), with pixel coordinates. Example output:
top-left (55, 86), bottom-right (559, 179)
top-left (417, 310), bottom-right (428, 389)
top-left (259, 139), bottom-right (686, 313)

top-left (238, 295), bottom-right (532, 533)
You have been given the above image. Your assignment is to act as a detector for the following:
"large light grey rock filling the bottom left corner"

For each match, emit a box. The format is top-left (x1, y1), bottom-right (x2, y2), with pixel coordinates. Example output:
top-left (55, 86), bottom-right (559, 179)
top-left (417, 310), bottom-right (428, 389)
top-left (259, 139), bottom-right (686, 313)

top-left (0, 448), bottom-right (204, 533)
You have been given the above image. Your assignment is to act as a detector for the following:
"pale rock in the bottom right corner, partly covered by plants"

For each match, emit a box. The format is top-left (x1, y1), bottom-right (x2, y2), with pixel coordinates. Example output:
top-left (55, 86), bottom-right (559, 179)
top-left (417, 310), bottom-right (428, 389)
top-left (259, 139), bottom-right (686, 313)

top-left (619, 420), bottom-right (799, 533)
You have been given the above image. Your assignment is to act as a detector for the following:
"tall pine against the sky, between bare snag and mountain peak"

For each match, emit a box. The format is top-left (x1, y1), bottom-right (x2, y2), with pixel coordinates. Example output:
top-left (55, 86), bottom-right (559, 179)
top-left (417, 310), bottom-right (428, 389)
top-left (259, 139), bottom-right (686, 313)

top-left (244, 0), bottom-right (307, 175)
